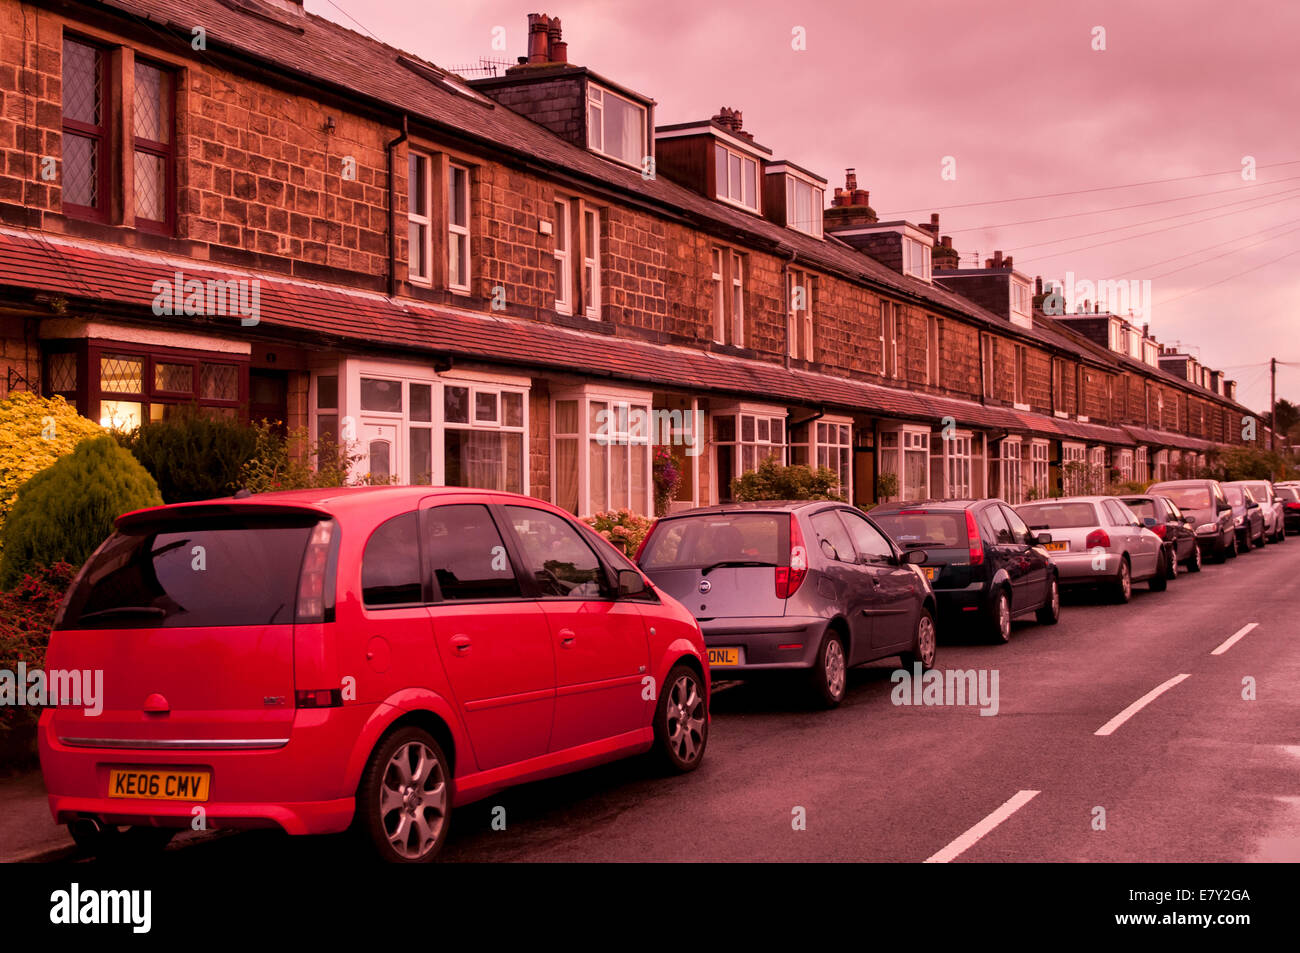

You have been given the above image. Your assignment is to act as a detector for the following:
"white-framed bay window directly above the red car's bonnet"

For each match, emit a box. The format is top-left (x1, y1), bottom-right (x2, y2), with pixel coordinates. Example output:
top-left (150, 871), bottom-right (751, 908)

top-left (550, 385), bottom-right (654, 516)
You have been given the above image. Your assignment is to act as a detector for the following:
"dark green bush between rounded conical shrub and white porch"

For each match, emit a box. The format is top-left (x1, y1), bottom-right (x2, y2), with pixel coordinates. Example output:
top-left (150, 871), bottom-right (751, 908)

top-left (118, 410), bottom-right (259, 503)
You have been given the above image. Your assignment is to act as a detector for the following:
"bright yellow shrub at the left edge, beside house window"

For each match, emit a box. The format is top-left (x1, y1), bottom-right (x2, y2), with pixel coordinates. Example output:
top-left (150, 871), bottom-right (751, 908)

top-left (0, 391), bottom-right (105, 553)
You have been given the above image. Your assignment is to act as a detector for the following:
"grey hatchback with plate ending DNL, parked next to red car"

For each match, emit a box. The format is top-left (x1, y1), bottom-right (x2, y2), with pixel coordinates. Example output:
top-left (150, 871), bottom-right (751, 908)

top-left (637, 501), bottom-right (936, 707)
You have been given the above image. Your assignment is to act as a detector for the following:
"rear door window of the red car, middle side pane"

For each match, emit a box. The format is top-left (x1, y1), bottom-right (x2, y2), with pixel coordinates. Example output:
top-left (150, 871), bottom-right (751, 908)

top-left (424, 503), bottom-right (523, 602)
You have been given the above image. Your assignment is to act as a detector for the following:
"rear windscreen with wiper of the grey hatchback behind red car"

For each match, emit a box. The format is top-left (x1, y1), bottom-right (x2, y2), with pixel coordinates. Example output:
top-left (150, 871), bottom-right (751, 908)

top-left (641, 512), bottom-right (790, 572)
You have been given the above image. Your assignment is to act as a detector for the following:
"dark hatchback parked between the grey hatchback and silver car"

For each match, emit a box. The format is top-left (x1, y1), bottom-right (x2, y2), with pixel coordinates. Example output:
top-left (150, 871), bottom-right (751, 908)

top-left (871, 499), bottom-right (1061, 642)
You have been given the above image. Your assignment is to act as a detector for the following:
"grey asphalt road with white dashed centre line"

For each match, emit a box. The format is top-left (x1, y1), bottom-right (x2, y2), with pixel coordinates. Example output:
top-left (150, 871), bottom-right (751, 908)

top-left (76, 537), bottom-right (1300, 866)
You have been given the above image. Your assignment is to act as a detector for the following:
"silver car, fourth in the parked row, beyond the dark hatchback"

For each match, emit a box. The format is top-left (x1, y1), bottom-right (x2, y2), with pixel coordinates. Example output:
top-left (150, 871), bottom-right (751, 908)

top-left (1015, 497), bottom-right (1169, 602)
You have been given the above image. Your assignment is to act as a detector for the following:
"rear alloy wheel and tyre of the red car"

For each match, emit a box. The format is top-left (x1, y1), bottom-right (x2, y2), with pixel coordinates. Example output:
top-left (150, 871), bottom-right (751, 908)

top-left (354, 725), bottom-right (451, 863)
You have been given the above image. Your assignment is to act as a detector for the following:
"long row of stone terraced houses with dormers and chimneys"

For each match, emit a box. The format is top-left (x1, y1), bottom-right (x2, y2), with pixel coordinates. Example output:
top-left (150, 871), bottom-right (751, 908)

top-left (0, 0), bottom-right (1262, 514)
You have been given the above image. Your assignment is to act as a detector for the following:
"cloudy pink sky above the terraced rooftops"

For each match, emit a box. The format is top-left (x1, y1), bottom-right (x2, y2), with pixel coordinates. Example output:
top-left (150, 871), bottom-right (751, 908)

top-left (307, 0), bottom-right (1300, 410)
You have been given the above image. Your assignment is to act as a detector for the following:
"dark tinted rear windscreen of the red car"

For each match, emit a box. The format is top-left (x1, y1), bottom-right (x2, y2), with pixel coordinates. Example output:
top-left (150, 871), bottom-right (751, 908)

top-left (59, 517), bottom-right (316, 629)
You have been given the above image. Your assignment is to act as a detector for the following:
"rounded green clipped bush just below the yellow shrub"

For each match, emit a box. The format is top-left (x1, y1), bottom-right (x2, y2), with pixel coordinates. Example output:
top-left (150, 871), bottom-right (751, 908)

top-left (0, 434), bottom-right (163, 589)
